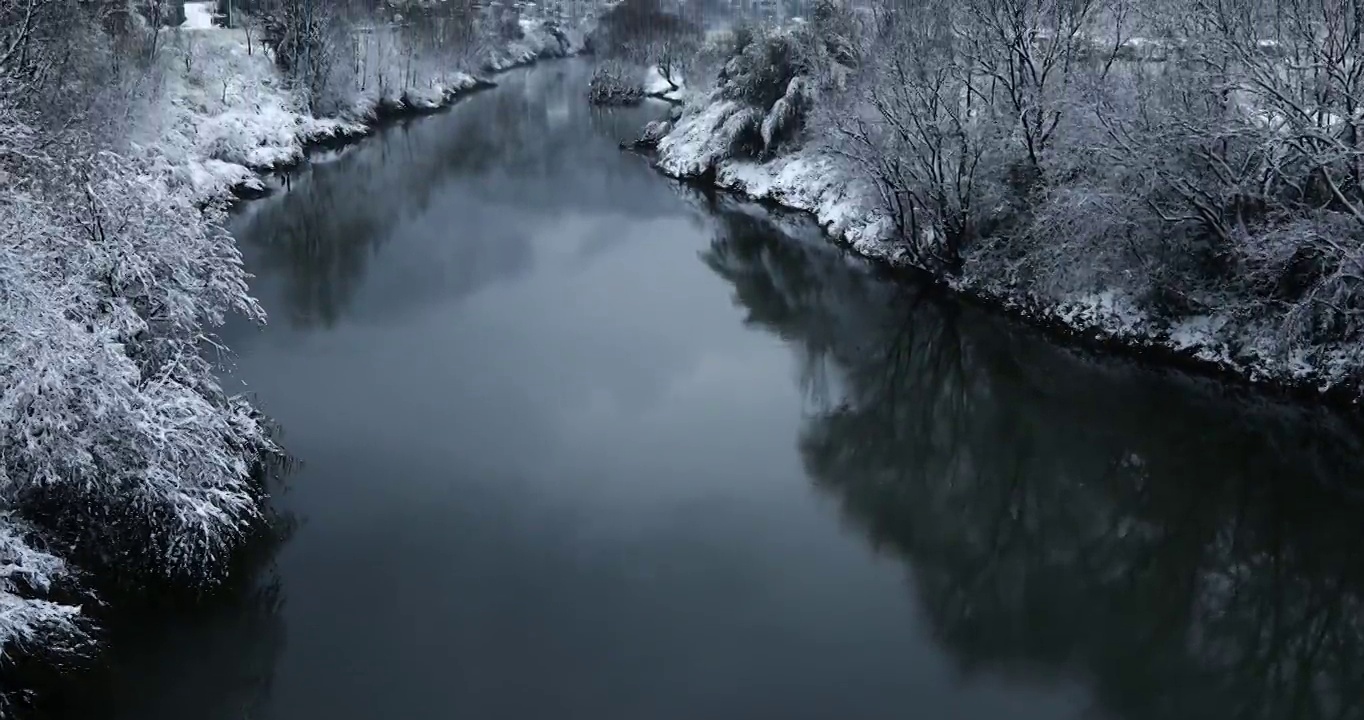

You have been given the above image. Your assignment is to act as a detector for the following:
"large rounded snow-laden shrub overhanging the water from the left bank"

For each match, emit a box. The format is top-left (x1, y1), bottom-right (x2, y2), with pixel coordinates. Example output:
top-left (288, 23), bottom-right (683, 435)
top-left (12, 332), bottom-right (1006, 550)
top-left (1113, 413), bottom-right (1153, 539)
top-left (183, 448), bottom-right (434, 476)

top-left (0, 153), bottom-right (271, 581)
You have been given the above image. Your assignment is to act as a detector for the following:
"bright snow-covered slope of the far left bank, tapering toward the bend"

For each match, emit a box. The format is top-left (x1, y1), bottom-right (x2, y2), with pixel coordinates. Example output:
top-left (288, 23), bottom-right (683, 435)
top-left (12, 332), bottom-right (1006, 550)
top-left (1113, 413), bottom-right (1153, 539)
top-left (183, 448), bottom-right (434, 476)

top-left (165, 3), bottom-right (587, 202)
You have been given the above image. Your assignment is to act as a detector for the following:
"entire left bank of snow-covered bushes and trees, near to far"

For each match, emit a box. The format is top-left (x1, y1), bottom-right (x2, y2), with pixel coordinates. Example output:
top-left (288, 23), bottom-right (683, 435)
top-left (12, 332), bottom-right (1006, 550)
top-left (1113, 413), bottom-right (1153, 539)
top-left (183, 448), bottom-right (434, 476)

top-left (0, 0), bottom-right (591, 716)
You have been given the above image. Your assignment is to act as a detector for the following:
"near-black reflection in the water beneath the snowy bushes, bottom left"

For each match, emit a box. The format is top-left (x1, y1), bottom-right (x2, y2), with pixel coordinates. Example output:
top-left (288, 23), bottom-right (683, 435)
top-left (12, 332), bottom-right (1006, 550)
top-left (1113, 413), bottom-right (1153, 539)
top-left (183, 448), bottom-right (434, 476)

top-left (31, 460), bottom-right (296, 720)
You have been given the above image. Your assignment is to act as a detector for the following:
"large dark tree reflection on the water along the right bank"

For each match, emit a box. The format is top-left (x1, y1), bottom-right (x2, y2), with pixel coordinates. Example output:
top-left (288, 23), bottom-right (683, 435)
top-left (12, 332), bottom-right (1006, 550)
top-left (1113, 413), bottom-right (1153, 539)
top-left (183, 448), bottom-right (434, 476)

top-left (707, 201), bottom-right (1364, 720)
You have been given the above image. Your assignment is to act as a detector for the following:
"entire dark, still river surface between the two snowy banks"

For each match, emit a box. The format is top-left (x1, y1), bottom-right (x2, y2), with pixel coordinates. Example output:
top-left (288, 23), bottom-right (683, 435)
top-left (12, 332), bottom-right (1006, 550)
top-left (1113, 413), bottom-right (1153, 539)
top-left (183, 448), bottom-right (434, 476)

top-left (37, 63), bottom-right (1364, 720)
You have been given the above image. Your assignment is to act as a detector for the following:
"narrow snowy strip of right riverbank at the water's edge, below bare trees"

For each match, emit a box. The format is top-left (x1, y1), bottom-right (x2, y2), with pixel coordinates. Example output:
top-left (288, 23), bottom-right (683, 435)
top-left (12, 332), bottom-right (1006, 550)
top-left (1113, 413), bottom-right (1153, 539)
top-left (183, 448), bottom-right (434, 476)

top-left (649, 100), bottom-right (1364, 404)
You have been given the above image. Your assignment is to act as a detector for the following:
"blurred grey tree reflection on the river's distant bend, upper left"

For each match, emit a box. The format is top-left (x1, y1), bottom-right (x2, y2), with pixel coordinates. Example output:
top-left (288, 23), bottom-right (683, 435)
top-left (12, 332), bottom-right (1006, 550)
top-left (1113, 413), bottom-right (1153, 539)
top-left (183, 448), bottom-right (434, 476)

top-left (235, 63), bottom-right (675, 326)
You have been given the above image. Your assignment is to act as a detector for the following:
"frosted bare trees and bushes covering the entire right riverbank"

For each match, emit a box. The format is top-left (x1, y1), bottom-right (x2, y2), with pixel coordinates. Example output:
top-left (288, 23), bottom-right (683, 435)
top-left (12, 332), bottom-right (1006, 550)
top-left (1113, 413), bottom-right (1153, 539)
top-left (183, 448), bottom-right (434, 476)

top-left (641, 0), bottom-right (1364, 401)
